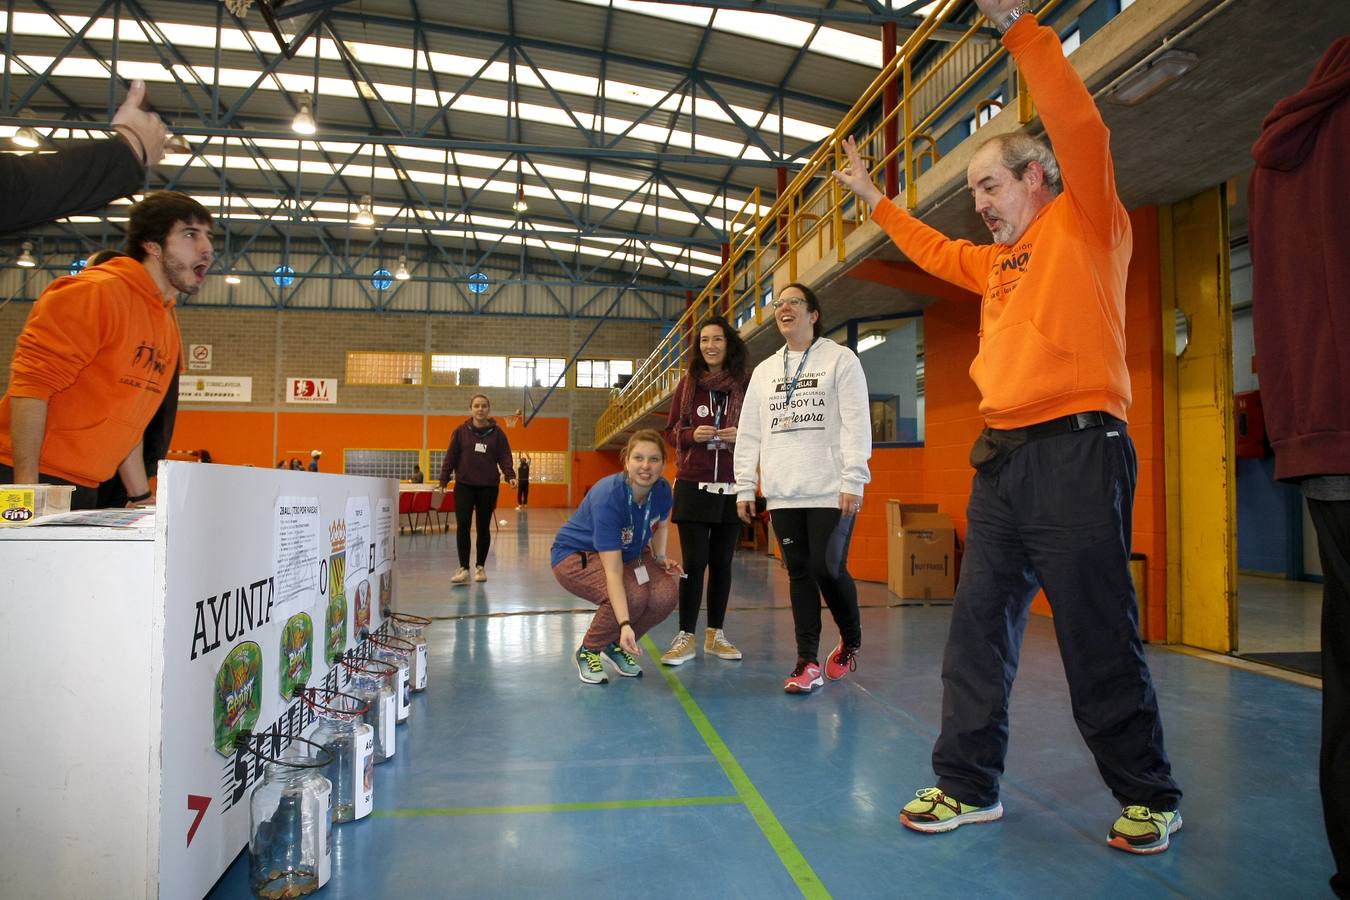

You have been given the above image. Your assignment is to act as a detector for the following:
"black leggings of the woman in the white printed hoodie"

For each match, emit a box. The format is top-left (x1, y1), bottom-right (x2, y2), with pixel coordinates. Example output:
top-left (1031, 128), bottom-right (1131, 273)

top-left (770, 507), bottom-right (863, 663)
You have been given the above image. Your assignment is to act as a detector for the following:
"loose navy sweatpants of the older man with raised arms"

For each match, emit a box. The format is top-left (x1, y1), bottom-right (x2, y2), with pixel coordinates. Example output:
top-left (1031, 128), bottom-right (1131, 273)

top-left (933, 424), bottom-right (1181, 810)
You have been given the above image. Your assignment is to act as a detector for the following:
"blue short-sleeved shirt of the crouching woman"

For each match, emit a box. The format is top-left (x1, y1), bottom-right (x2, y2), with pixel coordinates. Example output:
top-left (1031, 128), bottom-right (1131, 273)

top-left (551, 472), bottom-right (675, 565)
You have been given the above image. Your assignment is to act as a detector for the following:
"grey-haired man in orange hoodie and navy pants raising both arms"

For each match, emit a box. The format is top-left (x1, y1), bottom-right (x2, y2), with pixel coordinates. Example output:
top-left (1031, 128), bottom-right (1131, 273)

top-left (836, 0), bottom-right (1181, 854)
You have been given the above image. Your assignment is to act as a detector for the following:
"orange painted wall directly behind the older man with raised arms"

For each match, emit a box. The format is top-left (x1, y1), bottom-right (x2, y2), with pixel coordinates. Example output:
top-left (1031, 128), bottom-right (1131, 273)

top-left (849, 206), bottom-right (1166, 641)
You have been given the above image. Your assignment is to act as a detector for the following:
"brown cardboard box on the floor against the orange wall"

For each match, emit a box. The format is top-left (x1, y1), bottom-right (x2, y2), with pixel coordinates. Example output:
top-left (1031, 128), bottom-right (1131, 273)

top-left (886, 501), bottom-right (956, 600)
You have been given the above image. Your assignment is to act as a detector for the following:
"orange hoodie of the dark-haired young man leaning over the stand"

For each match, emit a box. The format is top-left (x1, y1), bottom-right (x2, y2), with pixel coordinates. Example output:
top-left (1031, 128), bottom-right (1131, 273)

top-left (0, 258), bottom-right (180, 487)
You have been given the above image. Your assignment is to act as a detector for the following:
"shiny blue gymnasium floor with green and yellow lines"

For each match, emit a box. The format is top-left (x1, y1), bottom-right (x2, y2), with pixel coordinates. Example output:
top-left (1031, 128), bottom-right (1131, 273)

top-left (208, 510), bottom-right (1331, 900)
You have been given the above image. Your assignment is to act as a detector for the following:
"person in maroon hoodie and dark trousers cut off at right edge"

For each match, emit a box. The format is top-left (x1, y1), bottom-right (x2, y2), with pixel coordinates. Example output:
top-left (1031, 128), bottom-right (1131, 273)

top-left (1247, 36), bottom-right (1350, 899)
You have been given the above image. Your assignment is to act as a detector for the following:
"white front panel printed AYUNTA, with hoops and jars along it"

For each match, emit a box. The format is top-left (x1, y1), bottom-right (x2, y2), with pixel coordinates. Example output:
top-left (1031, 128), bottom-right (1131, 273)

top-left (153, 463), bottom-right (398, 897)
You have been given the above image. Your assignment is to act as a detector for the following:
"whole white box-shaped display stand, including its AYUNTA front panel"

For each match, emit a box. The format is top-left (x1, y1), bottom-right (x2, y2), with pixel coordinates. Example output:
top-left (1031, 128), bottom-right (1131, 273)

top-left (0, 463), bottom-right (398, 900)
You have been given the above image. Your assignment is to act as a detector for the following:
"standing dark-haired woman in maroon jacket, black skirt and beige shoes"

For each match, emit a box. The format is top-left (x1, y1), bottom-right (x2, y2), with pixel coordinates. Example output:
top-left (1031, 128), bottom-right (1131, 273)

top-left (662, 316), bottom-right (749, 665)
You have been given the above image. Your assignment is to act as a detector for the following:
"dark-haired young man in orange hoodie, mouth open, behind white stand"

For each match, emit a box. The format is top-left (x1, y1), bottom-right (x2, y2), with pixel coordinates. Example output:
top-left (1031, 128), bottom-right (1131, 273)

top-left (0, 190), bottom-right (213, 509)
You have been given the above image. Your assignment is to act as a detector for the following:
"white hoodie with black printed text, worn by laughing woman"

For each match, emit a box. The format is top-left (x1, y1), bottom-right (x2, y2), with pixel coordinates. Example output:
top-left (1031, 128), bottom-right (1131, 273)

top-left (736, 337), bottom-right (872, 509)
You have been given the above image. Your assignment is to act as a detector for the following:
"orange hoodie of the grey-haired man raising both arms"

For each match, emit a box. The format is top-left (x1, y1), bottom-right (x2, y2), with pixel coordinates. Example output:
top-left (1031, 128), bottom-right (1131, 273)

top-left (872, 15), bottom-right (1133, 428)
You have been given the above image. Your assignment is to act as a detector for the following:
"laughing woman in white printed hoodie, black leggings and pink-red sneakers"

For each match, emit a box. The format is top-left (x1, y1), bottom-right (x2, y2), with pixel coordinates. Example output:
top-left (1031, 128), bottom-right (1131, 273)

top-left (736, 285), bottom-right (872, 694)
